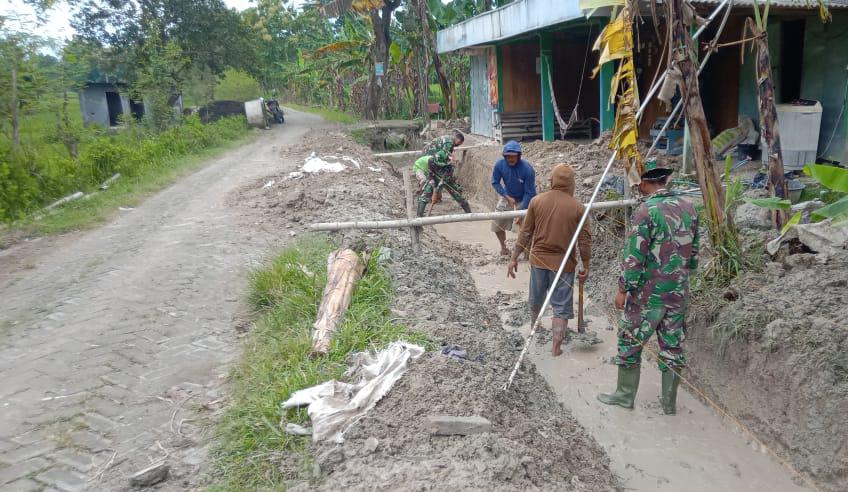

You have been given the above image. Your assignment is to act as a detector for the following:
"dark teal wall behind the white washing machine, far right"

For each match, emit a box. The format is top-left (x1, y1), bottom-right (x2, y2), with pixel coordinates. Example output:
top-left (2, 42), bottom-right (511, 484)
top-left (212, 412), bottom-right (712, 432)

top-left (801, 10), bottom-right (848, 162)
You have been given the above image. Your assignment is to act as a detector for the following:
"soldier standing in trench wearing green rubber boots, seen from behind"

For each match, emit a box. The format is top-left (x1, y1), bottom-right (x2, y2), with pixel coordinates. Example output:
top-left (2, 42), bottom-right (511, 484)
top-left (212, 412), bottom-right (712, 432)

top-left (598, 162), bottom-right (699, 415)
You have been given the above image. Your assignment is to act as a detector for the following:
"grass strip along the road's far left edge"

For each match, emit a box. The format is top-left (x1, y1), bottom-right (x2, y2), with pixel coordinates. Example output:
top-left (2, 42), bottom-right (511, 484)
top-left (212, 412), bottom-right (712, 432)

top-left (0, 132), bottom-right (256, 240)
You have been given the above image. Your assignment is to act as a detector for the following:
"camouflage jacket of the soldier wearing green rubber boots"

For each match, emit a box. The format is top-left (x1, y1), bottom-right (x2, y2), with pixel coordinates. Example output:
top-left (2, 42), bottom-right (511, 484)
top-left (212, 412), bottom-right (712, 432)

top-left (618, 190), bottom-right (700, 304)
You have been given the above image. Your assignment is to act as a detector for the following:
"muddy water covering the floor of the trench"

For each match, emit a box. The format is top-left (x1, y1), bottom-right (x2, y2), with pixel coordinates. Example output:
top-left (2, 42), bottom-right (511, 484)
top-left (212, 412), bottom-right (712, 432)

top-left (436, 217), bottom-right (805, 491)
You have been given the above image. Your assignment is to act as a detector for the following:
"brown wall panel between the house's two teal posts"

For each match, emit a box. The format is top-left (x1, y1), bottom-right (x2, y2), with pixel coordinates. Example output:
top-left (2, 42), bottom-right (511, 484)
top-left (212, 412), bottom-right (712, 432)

top-left (499, 42), bottom-right (542, 113)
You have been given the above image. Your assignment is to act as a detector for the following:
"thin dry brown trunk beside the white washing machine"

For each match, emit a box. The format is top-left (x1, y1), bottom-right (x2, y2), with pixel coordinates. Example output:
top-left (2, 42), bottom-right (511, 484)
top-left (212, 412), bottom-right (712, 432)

top-left (748, 19), bottom-right (787, 230)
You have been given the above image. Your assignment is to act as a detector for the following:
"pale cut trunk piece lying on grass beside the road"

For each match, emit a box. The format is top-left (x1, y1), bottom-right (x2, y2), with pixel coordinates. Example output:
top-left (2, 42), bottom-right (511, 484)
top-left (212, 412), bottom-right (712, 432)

top-left (312, 249), bottom-right (365, 355)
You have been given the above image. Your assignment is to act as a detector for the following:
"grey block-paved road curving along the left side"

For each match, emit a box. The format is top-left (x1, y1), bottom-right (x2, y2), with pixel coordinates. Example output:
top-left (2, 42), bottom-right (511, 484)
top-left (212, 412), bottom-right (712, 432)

top-left (0, 111), bottom-right (321, 490)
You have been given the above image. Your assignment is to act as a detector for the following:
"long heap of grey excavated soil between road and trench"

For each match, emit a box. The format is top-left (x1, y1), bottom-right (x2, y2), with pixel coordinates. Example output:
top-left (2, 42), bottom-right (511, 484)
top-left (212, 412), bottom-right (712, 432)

top-left (234, 134), bottom-right (619, 491)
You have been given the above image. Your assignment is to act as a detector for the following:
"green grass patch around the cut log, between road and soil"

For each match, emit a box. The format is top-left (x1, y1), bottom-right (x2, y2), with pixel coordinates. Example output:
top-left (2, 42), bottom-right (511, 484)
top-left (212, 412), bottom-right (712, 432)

top-left (212, 236), bottom-right (427, 491)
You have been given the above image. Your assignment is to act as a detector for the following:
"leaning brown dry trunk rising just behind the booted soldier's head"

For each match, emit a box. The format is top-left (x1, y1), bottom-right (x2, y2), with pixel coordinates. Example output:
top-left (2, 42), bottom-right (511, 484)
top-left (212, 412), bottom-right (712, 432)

top-left (666, 0), bottom-right (732, 247)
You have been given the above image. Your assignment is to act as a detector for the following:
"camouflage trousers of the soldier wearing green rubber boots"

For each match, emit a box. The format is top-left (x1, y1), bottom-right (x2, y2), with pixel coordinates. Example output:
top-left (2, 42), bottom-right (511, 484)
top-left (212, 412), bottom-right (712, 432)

top-left (615, 299), bottom-right (686, 372)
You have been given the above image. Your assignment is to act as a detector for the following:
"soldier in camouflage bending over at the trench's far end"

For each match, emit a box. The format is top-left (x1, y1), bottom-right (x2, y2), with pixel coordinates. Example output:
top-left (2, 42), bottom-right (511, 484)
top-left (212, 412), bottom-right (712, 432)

top-left (418, 132), bottom-right (471, 217)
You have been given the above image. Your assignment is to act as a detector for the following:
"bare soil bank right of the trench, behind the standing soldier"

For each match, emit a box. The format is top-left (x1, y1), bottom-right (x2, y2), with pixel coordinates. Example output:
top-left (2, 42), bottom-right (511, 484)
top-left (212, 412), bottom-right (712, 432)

top-left (687, 252), bottom-right (848, 492)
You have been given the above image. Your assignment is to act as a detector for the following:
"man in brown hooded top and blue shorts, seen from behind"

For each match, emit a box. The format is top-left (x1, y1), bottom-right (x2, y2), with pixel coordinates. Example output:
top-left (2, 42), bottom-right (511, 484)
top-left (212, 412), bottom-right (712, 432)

top-left (507, 164), bottom-right (592, 357)
